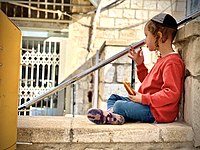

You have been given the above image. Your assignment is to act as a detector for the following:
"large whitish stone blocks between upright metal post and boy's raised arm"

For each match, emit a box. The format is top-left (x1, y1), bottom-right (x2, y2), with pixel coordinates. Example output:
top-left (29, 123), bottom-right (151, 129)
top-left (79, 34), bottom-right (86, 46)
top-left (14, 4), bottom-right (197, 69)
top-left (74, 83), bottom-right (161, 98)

top-left (98, 45), bottom-right (132, 109)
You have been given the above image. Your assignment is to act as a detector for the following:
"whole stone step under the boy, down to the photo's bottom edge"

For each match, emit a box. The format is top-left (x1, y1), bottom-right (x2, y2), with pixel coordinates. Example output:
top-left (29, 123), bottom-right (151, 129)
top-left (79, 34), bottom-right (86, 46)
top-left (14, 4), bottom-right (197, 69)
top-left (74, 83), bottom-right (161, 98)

top-left (17, 116), bottom-right (194, 150)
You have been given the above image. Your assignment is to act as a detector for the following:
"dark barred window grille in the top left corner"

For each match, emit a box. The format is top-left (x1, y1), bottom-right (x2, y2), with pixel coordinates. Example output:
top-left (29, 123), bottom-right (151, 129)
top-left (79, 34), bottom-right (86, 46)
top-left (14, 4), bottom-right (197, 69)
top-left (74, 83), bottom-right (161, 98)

top-left (1, 0), bottom-right (71, 21)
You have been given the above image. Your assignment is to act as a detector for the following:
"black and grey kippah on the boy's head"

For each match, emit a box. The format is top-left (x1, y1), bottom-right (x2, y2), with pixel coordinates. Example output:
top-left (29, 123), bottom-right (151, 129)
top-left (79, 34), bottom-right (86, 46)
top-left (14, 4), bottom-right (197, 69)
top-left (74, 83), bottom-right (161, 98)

top-left (151, 13), bottom-right (178, 29)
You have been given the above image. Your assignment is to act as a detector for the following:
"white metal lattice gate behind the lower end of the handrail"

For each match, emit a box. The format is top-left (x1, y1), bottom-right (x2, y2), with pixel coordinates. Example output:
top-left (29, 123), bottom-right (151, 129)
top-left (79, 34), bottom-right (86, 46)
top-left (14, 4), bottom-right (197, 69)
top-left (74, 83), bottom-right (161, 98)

top-left (19, 38), bottom-right (60, 115)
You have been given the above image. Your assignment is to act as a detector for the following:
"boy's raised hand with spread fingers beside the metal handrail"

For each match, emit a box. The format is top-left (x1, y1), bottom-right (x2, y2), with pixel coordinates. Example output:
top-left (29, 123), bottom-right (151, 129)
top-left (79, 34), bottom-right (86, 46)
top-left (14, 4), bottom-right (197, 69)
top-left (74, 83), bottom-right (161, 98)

top-left (128, 47), bottom-right (144, 65)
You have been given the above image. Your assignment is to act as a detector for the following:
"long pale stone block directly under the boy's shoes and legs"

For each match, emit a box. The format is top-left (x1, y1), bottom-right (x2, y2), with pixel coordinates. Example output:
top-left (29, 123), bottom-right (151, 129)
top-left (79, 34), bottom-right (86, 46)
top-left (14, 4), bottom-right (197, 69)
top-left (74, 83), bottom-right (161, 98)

top-left (72, 117), bottom-right (161, 143)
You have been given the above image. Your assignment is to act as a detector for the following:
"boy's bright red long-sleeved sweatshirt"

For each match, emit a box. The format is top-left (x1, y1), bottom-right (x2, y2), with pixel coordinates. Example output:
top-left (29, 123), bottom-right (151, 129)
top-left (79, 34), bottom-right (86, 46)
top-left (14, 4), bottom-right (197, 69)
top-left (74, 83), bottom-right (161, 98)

top-left (137, 53), bottom-right (184, 122)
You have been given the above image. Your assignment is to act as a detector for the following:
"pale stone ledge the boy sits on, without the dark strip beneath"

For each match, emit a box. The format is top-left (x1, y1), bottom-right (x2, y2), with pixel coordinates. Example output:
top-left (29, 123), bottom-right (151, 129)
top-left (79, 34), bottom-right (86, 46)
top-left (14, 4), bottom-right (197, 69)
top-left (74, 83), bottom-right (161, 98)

top-left (17, 116), bottom-right (193, 147)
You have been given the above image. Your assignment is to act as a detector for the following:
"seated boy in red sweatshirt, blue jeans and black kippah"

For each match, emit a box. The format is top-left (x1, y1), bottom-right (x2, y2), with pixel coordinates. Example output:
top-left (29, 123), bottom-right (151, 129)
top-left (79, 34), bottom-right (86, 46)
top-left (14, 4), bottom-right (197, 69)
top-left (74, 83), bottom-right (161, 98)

top-left (87, 13), bottom-right (184, 125)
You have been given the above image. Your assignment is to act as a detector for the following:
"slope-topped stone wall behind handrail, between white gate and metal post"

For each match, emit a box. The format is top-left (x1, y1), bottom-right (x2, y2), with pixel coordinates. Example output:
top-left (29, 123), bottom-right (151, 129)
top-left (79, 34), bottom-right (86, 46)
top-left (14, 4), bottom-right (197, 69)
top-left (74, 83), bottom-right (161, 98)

top-left (65, 56), bottom-right (95, 115)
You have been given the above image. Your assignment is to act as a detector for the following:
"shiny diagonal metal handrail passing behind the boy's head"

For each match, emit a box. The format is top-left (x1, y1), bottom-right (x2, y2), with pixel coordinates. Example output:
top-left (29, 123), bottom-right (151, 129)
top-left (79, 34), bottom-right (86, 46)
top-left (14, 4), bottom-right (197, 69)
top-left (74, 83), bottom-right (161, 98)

top-left (18, 11), bottom-right (200, 110)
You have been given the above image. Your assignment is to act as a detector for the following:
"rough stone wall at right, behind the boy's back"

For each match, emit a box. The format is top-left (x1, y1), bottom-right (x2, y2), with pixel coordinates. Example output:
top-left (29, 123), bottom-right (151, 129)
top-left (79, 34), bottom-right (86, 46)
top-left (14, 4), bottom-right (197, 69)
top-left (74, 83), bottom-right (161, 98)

top-left (175, 20), bottom-right (200, 146)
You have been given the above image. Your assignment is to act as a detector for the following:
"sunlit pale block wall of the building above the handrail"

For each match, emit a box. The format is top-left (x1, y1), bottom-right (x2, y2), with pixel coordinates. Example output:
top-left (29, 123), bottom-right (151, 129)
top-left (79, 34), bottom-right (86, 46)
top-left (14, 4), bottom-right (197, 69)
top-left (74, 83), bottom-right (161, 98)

top-left (66, 0), bottom-right (186, 74)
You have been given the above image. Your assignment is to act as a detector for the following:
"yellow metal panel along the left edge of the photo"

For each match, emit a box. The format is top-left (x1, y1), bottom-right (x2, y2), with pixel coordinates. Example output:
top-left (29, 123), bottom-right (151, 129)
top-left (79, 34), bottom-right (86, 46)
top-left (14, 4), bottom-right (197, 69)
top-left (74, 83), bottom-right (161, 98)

top-left (0, 10), bottom-right (21, 150)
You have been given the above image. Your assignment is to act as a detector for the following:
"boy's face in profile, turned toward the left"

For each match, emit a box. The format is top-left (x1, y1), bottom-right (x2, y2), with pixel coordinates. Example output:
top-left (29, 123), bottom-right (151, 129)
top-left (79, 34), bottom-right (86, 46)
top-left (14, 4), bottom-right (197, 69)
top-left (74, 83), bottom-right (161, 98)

top-left (144, 26), bottom-right (156, 51)
